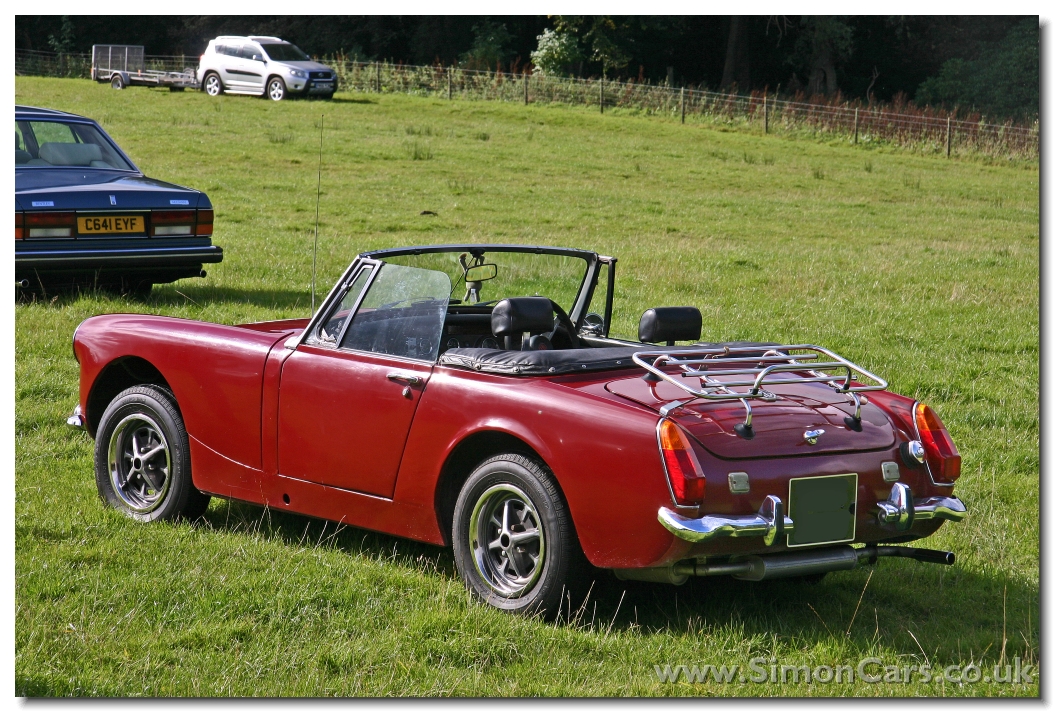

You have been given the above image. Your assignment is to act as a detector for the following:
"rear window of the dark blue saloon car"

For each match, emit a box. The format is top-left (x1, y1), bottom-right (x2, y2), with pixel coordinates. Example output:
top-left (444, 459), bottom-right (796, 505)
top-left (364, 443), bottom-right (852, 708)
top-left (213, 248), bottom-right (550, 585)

top-left (15, 121), bottom-right (135, 171)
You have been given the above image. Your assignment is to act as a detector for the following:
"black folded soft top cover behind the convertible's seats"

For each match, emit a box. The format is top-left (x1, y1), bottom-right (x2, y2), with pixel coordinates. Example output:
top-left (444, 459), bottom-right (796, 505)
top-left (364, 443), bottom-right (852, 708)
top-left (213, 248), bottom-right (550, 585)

top-left (440, 341), bottom-right (779, 376)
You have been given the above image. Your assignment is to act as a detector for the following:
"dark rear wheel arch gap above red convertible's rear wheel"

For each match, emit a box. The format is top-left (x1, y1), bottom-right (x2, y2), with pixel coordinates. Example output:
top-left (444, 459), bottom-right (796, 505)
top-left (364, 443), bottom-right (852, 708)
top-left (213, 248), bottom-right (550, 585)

top-left (435, 430), bottom-right (567, 547)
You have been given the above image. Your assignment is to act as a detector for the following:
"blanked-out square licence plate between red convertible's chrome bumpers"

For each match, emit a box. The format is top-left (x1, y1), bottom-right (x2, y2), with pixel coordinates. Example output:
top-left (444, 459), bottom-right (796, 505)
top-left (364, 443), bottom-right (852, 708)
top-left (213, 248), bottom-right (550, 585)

top-left (787, 473), bottom-right (857, 547)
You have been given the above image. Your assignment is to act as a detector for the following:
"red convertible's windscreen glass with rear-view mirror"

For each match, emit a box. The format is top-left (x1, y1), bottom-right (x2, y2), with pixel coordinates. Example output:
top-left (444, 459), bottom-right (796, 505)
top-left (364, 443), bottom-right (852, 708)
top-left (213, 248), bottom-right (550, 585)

top-left (384, 252), bottom-right (588, 312)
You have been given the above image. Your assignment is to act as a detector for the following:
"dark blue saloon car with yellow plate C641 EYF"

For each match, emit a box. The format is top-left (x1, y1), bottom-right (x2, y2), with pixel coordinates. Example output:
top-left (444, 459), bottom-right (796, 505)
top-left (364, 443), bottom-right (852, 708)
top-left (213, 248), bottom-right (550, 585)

top-left (15, 106), bottom-right (223, 295)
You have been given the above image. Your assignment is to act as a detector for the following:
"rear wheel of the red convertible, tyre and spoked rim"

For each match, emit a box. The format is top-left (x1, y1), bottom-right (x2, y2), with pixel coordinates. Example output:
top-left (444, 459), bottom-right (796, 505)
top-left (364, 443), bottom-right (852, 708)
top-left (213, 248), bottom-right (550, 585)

top-left (451, 454), bottom-right (586, 618)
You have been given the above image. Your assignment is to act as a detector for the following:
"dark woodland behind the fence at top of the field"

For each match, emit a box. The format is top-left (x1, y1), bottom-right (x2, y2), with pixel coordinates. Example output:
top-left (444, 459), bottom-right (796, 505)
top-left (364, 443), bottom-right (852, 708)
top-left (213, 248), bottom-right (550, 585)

top-left (15, 16), bottom-right (1039, 119)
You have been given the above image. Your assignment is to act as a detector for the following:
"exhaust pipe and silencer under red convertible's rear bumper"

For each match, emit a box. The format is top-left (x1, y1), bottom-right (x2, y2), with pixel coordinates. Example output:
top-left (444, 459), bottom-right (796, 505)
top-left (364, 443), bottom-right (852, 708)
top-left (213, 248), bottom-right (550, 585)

top-left (614, 545), bottom-right (955, 585)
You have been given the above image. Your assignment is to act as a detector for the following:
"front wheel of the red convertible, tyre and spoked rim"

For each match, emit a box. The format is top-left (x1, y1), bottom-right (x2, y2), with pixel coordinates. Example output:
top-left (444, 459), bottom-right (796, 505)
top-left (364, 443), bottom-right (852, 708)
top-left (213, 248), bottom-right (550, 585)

top-left (95, 385), bottom-right (209, 521)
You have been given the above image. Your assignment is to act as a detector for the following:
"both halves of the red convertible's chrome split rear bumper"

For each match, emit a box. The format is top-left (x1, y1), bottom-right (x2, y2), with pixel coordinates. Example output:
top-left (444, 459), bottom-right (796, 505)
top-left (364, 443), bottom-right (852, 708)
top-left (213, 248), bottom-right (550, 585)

top-left (659, 482), bottom-right (967, 547)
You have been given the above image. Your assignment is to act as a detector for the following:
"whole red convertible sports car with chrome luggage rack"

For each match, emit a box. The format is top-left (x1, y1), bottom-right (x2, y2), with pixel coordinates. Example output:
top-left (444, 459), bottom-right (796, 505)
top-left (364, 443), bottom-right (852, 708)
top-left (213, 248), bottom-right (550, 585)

top-left (69, 244), bottom-right (965, 614)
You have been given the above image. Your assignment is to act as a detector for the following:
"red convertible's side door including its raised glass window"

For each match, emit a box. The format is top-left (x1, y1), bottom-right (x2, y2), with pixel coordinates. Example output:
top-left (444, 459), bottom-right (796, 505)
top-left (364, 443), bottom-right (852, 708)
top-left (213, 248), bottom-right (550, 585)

top-left (278, 261), bottom-right (450, 497)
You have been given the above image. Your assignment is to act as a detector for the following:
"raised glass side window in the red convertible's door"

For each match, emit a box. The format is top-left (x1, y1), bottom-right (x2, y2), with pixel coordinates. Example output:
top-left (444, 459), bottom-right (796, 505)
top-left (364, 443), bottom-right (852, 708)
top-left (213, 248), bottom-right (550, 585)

top-left (340, 264), bottom-right (450, 361)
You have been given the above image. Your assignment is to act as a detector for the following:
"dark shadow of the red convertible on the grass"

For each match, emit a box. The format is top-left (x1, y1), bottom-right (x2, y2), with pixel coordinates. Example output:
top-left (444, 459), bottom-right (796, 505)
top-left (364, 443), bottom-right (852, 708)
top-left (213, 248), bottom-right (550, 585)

top-left (203, 495), bottom-right (1038, 666)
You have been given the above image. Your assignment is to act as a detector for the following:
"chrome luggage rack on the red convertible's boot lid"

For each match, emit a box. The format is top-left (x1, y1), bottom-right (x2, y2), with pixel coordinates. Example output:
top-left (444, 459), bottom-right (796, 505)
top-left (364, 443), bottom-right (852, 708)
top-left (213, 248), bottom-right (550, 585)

top-left (632, 344), bottom-right (889, 439)
